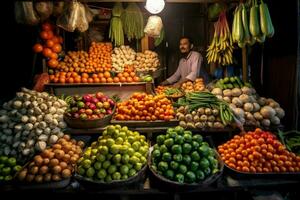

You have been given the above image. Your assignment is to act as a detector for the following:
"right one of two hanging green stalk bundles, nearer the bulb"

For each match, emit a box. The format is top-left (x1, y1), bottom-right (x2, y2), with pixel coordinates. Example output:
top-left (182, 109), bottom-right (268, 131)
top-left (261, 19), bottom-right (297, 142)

top-left (122, 3), bottom-right (144, 41)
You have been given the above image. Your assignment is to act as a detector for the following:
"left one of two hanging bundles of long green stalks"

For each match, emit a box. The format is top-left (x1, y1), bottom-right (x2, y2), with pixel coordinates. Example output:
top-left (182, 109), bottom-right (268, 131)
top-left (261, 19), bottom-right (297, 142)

top-left (109, 2), bottom-right (124, 46)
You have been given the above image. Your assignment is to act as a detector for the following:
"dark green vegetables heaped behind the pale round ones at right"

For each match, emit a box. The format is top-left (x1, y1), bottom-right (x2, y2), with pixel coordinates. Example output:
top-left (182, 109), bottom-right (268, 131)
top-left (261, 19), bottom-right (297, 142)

top-left (215, 76), bottom-right (252, 90)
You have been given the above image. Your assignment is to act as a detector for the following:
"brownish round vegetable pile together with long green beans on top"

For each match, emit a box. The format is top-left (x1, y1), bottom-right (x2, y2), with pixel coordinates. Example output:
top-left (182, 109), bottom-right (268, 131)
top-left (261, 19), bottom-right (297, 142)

top-left (176, 92), bottom-right (234, 129)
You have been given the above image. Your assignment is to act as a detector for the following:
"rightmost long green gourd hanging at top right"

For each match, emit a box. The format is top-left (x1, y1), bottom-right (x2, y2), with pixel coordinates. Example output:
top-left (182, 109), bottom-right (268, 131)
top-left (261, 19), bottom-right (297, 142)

top-left (259, 1), bottom-right (274, 37)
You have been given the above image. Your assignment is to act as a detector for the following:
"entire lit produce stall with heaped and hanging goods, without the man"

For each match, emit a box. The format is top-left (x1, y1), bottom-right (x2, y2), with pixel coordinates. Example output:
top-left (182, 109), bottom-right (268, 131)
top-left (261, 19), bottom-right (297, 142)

top-left (0, 0), bottom-right (300, 199)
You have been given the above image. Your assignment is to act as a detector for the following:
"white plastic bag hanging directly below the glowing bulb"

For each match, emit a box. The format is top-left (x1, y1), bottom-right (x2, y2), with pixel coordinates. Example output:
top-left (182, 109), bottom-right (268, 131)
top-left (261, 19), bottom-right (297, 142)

top-left (144, 15), bottom-right (163, 38)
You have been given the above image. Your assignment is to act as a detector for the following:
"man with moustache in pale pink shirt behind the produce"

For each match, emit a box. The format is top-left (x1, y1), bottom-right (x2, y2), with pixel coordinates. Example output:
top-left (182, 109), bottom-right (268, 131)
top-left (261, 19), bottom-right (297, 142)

top-left (161, 37), bottom-right (208, 88)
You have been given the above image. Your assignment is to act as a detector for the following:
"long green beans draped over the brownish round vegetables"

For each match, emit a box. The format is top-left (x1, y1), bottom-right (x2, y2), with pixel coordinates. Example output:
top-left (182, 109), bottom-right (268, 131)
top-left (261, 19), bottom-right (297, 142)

top-left (176, 92), bottom-right (234, 125)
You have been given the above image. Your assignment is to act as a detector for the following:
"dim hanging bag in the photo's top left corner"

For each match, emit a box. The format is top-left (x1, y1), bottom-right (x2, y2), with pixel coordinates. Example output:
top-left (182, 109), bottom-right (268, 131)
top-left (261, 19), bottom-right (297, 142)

top-left (15, 1), bottom-right (40, 26)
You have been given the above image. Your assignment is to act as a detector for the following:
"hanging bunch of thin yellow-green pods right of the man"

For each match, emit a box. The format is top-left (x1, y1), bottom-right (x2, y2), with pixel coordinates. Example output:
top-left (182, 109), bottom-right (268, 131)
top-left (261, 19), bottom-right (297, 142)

top-left (206, 11), bottom-right (233, 65)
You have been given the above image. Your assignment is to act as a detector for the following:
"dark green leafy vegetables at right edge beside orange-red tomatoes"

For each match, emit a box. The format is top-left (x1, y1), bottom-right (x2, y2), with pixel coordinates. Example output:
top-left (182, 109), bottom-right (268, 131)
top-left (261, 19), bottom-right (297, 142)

top-left (278, 130), bottom-right (300, 155)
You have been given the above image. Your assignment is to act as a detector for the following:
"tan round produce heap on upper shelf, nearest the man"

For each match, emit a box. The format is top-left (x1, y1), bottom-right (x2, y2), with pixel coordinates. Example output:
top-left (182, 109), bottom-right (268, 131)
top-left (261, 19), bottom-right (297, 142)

top-left (134, 50), bottom-right (160, 72)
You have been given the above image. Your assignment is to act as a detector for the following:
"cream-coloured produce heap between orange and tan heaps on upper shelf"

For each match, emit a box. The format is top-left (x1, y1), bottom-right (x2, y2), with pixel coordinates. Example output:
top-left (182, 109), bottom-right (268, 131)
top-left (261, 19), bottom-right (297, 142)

top-left (112, 45), bottom-right (136, 72)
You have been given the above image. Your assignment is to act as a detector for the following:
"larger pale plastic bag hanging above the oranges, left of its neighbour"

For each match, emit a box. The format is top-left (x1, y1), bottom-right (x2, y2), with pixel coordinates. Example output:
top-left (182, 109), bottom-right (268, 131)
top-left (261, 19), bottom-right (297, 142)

top-left (56, 1), bottom-right (81, 32)
